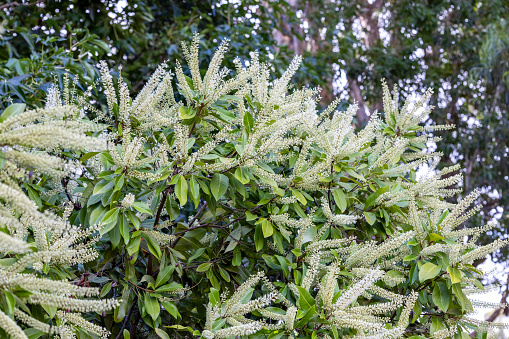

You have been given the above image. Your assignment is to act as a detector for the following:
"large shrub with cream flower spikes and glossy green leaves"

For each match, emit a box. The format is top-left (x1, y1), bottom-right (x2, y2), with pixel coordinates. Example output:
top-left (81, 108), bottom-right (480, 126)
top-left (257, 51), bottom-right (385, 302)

top-left (0, 37), bottom-right (507, 339)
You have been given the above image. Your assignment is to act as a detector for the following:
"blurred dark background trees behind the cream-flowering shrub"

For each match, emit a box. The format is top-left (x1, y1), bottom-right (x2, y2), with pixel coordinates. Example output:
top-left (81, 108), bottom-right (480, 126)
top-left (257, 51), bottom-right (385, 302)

top-left (0, 0), bottom-right (509, 282)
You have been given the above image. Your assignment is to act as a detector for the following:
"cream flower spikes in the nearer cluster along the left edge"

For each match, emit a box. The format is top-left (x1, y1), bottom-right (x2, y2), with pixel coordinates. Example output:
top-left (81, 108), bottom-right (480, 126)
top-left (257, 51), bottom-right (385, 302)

top-left (0, 95), bottom-right (118, 339)
